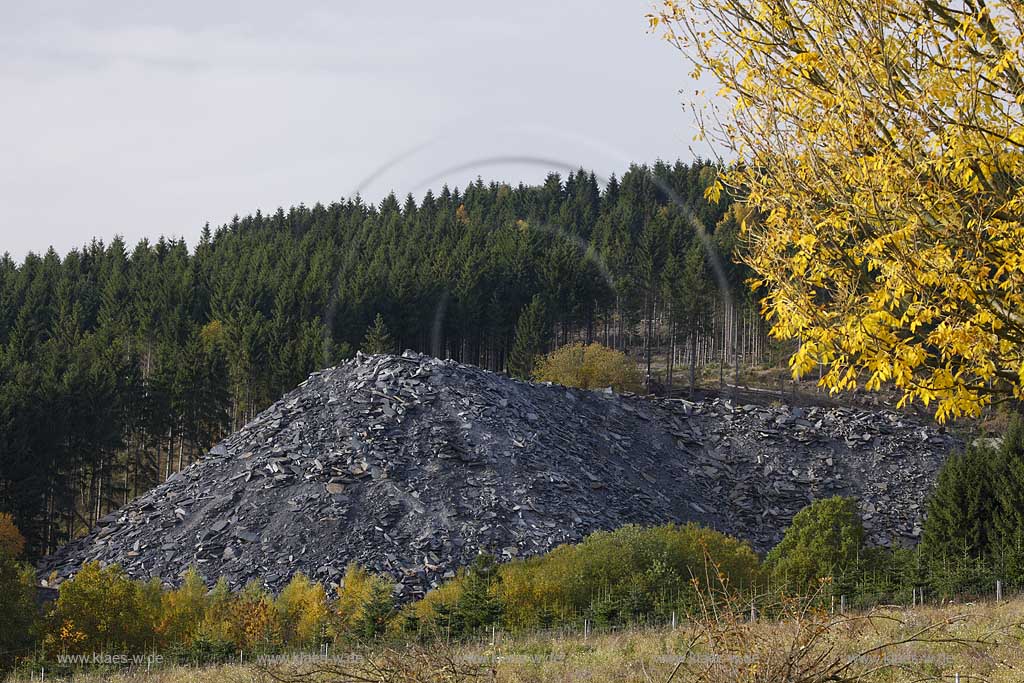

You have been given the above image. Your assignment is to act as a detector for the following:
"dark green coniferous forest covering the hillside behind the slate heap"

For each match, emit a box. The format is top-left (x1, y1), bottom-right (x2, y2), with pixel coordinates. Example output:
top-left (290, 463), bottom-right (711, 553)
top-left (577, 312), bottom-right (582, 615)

top-left (0, 161), bottom-right (767, 554)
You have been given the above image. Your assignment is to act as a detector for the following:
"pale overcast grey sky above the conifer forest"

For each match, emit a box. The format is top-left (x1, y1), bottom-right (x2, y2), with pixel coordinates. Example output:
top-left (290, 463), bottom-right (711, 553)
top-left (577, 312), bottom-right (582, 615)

top-left (0, 0), bottom-right (696, 259)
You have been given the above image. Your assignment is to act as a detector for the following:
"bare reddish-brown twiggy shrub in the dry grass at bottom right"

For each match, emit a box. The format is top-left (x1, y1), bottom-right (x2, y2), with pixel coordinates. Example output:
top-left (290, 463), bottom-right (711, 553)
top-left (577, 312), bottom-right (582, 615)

top-left (668, 561), bottom-right (1006, 683)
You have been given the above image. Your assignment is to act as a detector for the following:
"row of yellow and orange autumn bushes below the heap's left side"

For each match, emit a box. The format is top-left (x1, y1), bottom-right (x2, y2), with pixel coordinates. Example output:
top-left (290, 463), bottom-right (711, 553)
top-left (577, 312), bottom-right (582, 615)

top-left (35, 555), bottom-right (396, 665)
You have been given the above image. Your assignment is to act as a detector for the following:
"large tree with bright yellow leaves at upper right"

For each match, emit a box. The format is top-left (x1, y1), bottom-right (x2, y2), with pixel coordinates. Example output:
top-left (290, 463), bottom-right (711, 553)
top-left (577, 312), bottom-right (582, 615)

top-left (649, 0), bottom-right (1024, 421)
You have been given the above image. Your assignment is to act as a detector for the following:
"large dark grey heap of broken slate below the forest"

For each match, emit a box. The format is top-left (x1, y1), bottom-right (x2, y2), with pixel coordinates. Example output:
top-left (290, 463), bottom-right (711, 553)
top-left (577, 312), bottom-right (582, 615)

top-left (39, 351), bottom-right (956, 599)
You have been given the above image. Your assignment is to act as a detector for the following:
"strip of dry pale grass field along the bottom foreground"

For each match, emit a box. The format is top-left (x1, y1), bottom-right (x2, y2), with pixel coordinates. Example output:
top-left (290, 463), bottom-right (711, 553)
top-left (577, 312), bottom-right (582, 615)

top-left (13, 599), bottom-right (1024, 683)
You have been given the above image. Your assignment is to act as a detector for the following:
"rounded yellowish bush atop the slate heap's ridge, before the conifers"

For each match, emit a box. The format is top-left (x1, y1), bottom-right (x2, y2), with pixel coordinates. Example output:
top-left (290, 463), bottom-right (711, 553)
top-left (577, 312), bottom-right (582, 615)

top-left (534, 342), bottom-right (642, 391)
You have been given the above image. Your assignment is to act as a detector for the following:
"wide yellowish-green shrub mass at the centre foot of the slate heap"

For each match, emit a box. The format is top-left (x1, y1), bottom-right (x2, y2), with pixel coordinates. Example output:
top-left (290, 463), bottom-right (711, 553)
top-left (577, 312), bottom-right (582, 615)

top-left (407, 524), bottom-right (759, 636)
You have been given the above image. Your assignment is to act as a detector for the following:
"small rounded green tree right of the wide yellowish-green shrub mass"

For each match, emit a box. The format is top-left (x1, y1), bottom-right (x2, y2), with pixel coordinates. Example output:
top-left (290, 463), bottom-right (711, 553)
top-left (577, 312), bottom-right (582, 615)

top-left (765, 496), bottom-right (864, 594)
